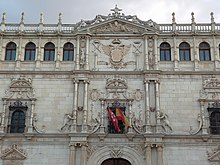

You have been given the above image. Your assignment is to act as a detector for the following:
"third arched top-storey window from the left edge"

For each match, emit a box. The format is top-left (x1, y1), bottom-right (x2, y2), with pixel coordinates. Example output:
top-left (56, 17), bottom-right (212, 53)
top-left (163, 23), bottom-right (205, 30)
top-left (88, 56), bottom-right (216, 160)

top-left (44, 42), bottom-right (55, 61)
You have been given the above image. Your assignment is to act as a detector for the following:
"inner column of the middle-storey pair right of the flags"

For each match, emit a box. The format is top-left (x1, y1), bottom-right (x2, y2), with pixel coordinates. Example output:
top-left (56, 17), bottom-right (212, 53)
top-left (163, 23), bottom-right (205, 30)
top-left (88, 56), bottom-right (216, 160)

top-left (144, 80), bottom-right (151, 133)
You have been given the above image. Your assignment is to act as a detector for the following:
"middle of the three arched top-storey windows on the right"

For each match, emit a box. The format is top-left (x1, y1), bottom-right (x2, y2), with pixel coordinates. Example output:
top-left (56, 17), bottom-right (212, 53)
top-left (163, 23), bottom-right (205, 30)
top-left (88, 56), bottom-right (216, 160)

top-left (179, 42), bottom-right (191, 61)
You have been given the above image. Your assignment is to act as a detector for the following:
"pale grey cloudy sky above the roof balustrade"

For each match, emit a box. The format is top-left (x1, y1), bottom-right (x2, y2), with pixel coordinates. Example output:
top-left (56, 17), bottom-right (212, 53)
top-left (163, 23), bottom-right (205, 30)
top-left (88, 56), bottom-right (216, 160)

top-left (0, 0), bottom-right (220, 23)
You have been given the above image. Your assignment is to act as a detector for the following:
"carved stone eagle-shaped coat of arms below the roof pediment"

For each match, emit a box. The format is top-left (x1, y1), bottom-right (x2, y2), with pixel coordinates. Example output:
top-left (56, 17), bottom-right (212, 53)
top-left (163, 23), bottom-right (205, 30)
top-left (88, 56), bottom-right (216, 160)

top-left (102, 39), bottom-right (130, 69)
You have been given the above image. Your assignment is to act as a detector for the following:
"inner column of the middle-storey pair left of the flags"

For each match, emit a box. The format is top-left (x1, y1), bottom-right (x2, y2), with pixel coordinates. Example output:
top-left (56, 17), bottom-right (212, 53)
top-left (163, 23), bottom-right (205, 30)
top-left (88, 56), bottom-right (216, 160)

top-left (82, 80), bottom-right (89, 132)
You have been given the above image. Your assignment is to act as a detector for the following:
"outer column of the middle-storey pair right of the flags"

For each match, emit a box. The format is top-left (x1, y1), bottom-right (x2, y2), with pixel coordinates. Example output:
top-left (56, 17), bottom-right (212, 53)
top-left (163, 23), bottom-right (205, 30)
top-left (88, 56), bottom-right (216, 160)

top-left (154, 80), bottom-right (161, 133)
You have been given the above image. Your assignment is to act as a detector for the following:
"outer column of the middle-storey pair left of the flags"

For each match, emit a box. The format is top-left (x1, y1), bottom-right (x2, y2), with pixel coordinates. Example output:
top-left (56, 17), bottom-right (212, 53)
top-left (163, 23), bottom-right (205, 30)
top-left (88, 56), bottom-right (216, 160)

top-left (72, 79), bottom-right (79, 132)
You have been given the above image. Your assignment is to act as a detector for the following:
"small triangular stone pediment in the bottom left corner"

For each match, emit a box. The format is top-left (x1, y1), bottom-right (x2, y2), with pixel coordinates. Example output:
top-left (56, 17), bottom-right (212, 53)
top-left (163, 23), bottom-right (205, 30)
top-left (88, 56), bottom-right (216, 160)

top-left (1, 144), bottom-right (27, 160)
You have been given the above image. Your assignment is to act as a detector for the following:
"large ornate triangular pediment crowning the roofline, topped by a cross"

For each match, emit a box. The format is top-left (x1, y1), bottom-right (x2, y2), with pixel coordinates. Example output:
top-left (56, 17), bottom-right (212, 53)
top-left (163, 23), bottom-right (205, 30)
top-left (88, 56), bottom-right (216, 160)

top-left (75, 5), bottom-right (159, 34)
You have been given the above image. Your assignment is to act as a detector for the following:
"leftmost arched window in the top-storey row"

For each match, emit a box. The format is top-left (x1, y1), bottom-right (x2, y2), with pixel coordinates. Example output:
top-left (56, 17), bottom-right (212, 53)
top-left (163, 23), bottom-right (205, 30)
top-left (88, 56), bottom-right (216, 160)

top-left (5, 42), bottom-right (17, 61)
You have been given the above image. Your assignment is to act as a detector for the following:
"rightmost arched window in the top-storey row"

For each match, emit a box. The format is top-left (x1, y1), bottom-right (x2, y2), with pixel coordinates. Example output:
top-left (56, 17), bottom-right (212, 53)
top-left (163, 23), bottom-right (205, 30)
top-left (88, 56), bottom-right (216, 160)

top-left (199, 42), bottom-right (211, 61)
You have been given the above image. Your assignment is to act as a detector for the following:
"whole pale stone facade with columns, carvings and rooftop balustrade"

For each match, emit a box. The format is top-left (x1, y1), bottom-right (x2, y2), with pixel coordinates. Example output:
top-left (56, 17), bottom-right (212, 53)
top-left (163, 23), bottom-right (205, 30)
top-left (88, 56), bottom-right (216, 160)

top-left (0, 6), bottom-right (220, 165)
